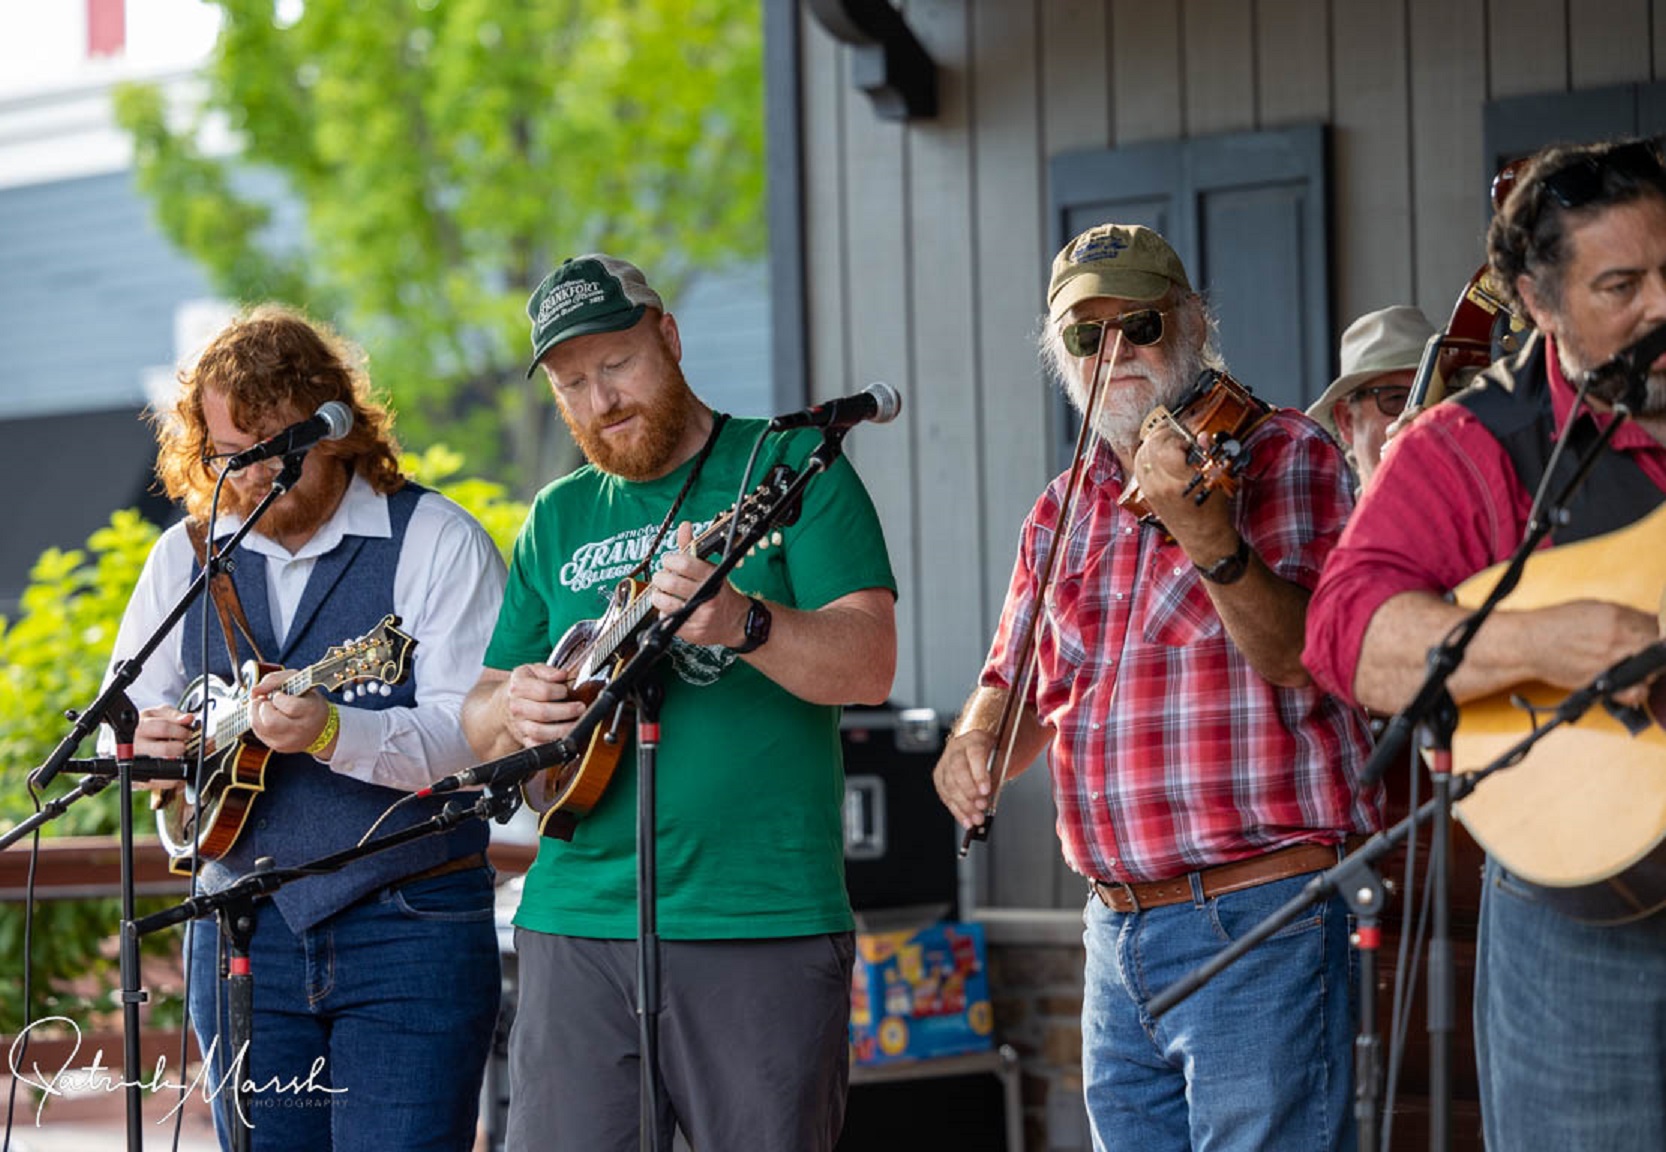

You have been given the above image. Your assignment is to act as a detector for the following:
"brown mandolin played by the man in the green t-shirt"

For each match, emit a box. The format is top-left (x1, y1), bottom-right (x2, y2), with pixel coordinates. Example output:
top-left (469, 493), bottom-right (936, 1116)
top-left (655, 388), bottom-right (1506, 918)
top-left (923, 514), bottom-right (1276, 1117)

top-left (521, 463), bottom-right (798, 840)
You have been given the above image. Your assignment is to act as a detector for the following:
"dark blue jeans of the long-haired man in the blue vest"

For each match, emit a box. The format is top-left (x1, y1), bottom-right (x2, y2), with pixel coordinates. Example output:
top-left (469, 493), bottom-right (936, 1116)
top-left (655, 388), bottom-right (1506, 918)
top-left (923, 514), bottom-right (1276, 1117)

top-left (190, 867), bottom-right (500, 1152)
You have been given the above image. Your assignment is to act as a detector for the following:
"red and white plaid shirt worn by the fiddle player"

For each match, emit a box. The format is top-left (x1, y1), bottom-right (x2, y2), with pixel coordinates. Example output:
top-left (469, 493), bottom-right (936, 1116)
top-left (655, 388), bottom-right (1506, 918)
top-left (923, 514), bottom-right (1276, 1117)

top-left (981, 410), bottom-right (1381, 882)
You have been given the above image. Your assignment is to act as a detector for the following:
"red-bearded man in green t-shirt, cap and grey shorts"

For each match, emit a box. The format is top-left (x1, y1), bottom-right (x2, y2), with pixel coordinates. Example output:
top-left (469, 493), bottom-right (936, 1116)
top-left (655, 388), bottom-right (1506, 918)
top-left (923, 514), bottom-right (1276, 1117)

top-left (463, 255), bottom-right (896, 1152)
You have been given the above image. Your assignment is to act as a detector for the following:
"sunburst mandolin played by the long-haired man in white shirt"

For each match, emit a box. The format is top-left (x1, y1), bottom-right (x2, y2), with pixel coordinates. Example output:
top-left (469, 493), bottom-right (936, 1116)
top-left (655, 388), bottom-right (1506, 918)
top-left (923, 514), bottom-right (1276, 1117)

top-left (150, 614), bottom-right (417, 875)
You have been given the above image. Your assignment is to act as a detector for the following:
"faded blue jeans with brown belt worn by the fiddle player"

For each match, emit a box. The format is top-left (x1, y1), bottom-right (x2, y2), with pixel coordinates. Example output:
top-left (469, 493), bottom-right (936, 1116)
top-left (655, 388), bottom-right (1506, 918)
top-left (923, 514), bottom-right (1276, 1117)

top-left (1081, 877), bottom-right (1358, 1152)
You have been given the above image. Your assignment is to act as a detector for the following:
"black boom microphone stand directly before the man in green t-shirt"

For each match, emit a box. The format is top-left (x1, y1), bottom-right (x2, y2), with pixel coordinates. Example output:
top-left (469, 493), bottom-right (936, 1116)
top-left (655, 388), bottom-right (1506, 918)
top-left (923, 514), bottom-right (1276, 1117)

top-left (479, 427), bottom-right (850, 1152)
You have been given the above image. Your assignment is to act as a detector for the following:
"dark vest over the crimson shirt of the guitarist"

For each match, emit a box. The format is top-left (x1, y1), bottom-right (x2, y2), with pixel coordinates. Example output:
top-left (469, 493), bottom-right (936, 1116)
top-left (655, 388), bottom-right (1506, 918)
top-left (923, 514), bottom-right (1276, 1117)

top-left (1453, 335), bottom-right (1666, 543)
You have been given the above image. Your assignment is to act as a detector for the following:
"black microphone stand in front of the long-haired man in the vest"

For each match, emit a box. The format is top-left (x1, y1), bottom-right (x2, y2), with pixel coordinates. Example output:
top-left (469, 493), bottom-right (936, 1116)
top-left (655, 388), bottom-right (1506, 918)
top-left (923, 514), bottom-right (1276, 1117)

top-left (18, 452), bottom-right (305, 1152)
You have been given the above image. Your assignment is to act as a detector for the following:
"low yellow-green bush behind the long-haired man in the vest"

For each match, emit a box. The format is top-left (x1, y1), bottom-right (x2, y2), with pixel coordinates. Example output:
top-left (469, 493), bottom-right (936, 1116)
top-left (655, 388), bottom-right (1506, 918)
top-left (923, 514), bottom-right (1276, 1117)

top-left (0, 456), bottom-right (526, 1035)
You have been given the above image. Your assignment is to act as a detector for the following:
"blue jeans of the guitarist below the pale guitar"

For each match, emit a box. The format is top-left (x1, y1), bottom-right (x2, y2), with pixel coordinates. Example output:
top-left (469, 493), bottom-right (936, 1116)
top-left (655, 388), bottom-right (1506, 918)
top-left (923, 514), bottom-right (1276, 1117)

top-left (1474, 859), bottom-right (1666, 1152)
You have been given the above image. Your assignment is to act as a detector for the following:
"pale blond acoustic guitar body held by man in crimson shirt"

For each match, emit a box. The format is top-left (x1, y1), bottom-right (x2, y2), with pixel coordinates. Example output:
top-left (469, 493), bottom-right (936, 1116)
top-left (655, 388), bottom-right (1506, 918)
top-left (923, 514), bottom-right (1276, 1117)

top-left (1453, 505), bottom-right (1666, 924)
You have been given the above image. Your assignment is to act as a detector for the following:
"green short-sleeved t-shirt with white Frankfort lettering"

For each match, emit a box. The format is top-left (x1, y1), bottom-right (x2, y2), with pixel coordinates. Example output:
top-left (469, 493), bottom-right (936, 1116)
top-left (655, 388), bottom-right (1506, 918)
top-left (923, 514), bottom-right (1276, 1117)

top-left (485, 420), bottom-right (896, 940)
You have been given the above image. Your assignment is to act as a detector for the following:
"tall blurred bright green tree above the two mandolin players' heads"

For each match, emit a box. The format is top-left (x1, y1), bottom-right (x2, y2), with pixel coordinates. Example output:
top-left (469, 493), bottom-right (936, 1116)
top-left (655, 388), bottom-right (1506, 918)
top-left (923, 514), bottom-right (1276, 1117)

top-left (117, 0), bottom-right (766, 490)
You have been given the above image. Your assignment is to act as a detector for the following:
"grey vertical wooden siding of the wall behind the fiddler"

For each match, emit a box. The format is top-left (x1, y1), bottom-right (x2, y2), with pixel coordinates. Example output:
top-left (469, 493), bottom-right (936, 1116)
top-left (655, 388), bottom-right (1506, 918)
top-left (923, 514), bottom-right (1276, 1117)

top-left (801, 0), bottom-right (1666, 904)
